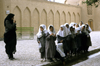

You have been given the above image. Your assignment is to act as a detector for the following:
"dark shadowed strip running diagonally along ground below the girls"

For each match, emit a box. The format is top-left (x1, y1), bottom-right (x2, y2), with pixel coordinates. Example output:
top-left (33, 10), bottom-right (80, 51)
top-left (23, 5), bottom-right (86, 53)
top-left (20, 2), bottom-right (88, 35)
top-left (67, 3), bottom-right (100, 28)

top-left (42, 48), bottom-right (100, 66)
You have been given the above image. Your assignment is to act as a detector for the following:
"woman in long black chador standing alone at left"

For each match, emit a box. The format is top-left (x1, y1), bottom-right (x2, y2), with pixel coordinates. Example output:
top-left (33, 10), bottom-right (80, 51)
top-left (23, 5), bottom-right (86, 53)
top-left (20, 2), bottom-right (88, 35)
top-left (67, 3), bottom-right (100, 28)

top-left (4, 14), bottom-right (17, 60)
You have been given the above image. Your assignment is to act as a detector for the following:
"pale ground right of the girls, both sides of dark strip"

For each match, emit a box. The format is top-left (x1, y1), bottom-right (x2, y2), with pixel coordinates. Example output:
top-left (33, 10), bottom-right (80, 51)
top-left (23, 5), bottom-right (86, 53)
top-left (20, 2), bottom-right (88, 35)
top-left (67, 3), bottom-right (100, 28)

top-left (72, 32), bottom-right (100, 66)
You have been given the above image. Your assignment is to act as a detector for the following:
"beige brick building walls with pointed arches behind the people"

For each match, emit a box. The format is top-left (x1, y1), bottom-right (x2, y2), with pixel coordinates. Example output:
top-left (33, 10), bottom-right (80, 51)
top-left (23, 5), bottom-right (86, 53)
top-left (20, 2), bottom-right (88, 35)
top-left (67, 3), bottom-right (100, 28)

top-left (0, 0), bottom-right (100, 38)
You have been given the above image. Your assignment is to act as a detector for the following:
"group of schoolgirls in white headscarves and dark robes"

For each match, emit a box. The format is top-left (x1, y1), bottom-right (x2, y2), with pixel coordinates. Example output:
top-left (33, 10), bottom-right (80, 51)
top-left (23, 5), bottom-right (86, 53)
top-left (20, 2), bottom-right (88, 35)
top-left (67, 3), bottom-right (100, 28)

top-left (37, 21), bottom-right (92, 63)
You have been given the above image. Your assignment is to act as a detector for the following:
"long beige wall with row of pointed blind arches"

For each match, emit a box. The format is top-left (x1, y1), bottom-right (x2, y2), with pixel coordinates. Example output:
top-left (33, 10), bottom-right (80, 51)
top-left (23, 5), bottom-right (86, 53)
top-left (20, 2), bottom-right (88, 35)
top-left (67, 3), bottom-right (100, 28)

top-left (11, 0), bottom-right (81, 34)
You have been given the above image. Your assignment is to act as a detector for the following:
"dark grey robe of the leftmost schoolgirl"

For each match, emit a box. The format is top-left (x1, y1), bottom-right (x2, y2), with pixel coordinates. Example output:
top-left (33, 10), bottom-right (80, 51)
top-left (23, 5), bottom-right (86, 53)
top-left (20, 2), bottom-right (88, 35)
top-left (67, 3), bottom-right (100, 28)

top-left (37, 32), bottom-right (46, 58)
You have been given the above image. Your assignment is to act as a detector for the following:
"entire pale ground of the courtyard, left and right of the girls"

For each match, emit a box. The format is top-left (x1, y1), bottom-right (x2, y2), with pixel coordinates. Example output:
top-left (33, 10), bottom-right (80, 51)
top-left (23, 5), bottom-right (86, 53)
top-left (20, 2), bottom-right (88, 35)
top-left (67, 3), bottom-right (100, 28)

top-left (0, 32), bottom-right (100, 66)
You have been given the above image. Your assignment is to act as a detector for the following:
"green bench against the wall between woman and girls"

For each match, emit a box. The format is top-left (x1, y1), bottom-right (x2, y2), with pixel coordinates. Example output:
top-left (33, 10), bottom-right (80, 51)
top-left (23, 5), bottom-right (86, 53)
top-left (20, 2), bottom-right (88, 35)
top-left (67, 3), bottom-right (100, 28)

top-left (17, 27), bottom-right (34, 39)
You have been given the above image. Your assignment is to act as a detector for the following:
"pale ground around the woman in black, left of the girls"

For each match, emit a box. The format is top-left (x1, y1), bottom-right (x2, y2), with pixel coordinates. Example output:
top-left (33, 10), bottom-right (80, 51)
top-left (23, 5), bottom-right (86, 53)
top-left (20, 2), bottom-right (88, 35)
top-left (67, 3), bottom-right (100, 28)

top-left (0, 39), bottom-right (49, 66)
